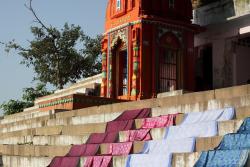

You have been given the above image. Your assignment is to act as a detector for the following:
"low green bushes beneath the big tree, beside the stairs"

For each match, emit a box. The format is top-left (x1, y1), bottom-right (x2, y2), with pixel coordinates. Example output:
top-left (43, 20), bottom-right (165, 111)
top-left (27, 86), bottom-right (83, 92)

top-left (0, 84), bottom-right (53, 115)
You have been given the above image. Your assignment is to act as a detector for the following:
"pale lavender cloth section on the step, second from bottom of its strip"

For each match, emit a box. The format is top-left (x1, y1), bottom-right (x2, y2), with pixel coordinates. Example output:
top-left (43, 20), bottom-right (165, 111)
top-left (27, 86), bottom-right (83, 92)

top-left (141, 138), bottom-right (195, 154)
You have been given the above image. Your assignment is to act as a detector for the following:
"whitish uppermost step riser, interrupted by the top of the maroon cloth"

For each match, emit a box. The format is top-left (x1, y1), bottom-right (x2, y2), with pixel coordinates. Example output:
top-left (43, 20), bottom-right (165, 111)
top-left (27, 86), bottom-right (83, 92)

top-left (0, 95), bottom-right (250, 133)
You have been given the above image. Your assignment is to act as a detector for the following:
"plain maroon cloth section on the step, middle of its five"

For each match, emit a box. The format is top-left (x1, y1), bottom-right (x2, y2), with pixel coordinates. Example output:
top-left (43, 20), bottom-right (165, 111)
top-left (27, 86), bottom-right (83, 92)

top-left (86, 132), bottom-right (118, 144)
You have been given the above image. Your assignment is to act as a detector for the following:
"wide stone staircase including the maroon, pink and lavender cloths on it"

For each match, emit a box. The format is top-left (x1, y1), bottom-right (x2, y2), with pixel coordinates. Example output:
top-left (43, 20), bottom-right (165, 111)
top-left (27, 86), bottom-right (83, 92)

top-left (0, 85), bottom-right (250, 167)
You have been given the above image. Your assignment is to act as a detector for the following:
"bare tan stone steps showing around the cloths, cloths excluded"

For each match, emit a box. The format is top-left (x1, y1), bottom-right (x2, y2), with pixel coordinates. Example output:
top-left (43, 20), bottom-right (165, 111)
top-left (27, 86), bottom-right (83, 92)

top-left (0, 85), bottom-right (250, 167)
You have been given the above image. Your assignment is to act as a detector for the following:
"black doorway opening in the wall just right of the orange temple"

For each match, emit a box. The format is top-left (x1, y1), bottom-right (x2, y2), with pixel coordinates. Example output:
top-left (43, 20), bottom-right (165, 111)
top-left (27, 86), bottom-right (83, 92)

top-left (195, 45), bottom-right (213, 91)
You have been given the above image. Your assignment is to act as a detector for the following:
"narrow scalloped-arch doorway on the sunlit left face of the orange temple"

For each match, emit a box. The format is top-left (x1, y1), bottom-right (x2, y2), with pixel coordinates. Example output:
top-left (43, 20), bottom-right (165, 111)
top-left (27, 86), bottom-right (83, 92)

top-left (112, 38), bottom-right (128, 98)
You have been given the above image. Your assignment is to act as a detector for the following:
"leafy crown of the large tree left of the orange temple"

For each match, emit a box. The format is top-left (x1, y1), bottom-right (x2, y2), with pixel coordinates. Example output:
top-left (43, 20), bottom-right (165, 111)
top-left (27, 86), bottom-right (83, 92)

top-left (6, 23), bottom-right (101, 89)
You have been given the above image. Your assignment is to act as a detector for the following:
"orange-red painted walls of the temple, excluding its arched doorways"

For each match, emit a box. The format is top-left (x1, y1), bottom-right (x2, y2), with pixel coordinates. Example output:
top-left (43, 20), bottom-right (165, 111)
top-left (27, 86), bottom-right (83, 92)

top-left (101, 0), bottom-right (199, 100)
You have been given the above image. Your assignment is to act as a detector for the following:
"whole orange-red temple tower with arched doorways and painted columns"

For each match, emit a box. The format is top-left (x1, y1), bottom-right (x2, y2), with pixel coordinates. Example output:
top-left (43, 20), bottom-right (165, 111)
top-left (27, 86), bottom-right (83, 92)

top-left (101, 0), bottom-right (199, 100)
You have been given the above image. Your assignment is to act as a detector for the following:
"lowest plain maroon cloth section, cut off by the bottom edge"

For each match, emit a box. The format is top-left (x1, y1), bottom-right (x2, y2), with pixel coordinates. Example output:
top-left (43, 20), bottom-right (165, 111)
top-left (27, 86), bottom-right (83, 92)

top-left (48, 157), bottom-right (80, 167)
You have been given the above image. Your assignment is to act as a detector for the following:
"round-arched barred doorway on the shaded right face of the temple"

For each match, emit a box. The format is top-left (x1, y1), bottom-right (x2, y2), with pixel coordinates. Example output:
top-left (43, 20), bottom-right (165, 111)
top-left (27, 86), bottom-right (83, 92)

top-left (158, 32), bottom-right (182, 93)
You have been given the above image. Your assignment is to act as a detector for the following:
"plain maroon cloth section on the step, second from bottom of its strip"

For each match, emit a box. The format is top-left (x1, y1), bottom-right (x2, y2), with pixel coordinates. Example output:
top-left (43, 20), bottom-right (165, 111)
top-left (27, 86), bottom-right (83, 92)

top-left (66, 144), bottom-right (99, 157)
